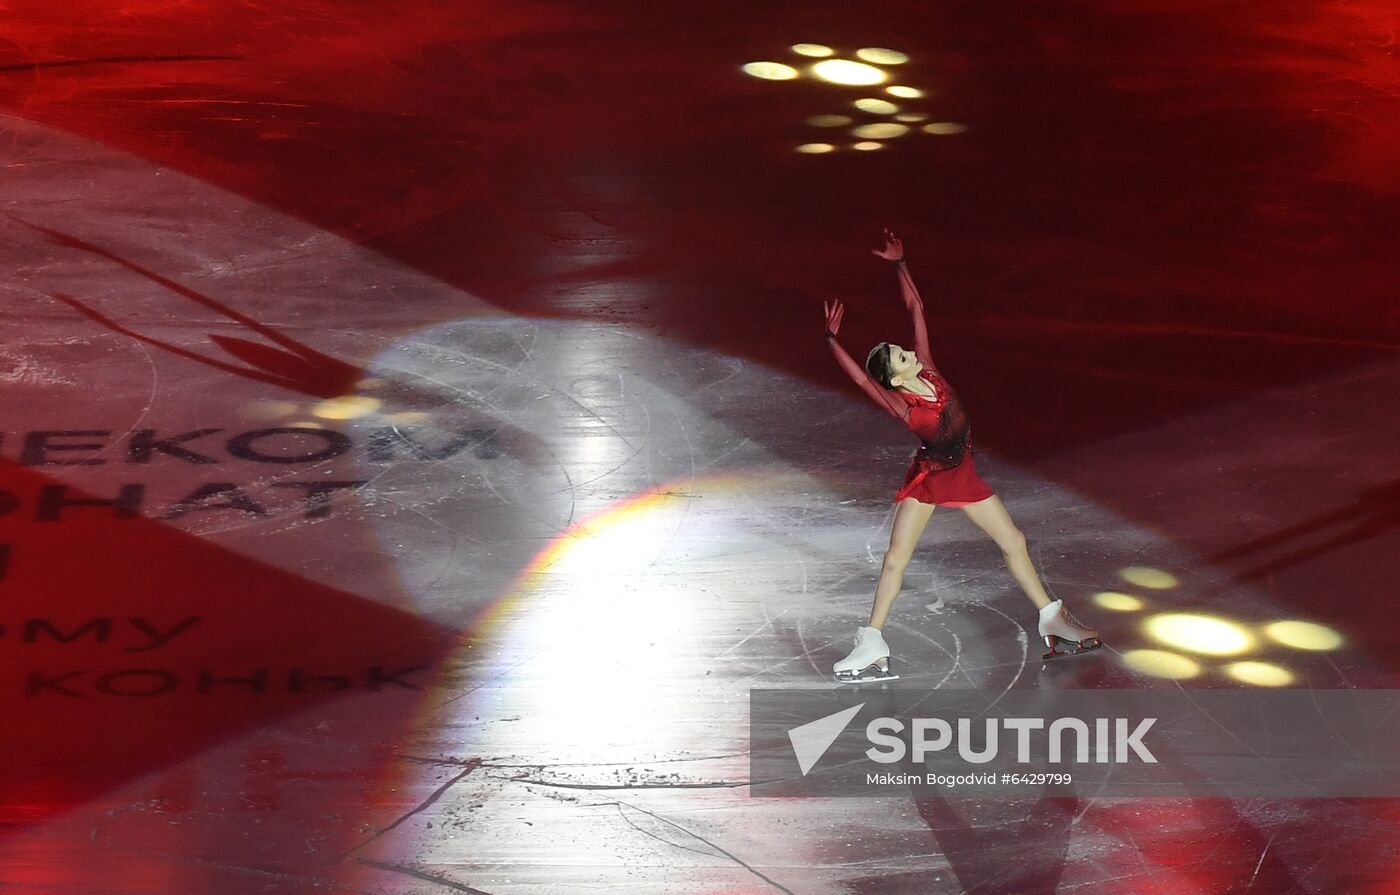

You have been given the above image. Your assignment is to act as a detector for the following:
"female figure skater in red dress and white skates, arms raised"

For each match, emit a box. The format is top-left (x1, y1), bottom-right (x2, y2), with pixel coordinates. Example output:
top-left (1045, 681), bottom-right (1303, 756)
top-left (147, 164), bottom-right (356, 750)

top-left (823, 230), bottom-right (1103, 682)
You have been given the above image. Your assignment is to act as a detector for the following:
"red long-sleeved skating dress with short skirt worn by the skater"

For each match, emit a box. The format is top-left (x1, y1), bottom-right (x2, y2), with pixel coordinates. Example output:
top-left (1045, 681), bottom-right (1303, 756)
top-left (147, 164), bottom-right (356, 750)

top-left (827, 278), bottom-right (994, 507)
